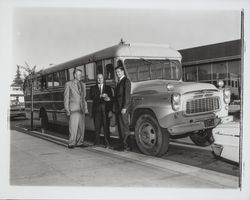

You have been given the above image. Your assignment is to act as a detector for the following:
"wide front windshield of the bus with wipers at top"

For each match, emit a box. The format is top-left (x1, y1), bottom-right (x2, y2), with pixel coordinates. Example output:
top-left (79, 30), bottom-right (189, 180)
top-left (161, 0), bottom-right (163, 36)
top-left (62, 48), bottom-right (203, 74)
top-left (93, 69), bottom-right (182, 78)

top-left (124, 58), bottom-right (181, 82)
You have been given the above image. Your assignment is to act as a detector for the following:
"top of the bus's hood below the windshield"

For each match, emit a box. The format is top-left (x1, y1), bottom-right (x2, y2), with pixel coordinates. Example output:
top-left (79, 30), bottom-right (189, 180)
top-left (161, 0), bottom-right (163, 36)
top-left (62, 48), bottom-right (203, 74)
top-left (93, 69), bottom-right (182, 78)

top-left (131, 80), bottom-right (218, 94)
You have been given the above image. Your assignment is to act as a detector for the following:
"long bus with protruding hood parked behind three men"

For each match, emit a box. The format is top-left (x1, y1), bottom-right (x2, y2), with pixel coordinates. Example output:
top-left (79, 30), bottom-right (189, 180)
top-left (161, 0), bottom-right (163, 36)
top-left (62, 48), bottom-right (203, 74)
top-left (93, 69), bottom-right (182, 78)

top-left (25, 42), bottom-right (230, 156)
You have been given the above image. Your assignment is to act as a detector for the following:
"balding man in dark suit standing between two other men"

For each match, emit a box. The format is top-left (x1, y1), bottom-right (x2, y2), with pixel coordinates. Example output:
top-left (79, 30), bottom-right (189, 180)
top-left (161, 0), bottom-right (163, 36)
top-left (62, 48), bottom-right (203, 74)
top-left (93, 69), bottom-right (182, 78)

top-left (89, 74), bottom-right (113, 148)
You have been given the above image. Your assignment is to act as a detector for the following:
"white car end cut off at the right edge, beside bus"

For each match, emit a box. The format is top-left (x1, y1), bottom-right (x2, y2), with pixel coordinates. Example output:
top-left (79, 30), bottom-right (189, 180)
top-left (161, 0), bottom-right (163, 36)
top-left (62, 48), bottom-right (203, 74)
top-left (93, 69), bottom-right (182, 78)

top-left (211, 116), bottom-right (240, 163)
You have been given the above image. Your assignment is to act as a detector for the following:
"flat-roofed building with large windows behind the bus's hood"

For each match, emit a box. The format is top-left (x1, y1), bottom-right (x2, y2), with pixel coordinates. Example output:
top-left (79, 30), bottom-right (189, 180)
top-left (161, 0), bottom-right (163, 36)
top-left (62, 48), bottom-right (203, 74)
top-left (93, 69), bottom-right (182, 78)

top-left (179, 40), bottom-right (241, 99)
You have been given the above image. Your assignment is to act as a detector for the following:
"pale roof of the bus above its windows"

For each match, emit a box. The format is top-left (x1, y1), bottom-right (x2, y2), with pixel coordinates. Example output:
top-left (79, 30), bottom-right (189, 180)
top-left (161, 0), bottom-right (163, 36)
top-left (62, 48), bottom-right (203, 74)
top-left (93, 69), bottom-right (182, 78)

top-left (38, 43), bottom-right (181, 74)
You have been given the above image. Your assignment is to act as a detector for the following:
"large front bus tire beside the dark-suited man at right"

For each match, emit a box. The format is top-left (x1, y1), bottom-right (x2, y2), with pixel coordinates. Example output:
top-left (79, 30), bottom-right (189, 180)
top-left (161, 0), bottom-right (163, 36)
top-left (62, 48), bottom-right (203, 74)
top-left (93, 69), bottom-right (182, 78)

top-left (135, 111), bottom-right (169, 157)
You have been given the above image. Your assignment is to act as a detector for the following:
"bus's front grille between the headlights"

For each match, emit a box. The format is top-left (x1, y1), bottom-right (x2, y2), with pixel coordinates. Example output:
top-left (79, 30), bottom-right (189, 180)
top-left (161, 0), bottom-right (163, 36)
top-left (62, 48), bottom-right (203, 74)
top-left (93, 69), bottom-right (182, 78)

top-left (186, 97), bottom-right (219, 115)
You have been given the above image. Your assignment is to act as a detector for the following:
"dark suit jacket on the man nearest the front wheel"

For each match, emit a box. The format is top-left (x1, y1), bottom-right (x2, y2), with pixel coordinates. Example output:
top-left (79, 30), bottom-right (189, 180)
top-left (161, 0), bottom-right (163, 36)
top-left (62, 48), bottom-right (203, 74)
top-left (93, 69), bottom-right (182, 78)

top-left (115, 77), bottom-right (131, 113)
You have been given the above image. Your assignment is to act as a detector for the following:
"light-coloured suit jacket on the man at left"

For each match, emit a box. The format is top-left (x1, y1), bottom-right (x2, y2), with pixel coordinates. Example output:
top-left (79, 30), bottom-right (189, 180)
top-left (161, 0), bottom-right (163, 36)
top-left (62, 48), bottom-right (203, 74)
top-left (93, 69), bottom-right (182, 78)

top-left (64, 80), bottom-right (88, 113)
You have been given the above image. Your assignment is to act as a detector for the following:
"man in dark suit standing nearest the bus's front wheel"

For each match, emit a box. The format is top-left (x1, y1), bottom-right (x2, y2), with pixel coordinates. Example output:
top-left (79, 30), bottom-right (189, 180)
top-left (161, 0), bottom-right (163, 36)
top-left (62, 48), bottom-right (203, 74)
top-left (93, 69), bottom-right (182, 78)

top-left (115, 62), bottom-right (131, 150)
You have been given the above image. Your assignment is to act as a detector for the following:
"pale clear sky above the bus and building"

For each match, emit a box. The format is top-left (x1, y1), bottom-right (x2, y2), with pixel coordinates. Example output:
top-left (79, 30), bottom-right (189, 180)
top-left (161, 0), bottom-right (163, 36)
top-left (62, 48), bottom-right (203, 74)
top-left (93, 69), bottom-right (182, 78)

top-left (13, 7), bottom-right (241, 73)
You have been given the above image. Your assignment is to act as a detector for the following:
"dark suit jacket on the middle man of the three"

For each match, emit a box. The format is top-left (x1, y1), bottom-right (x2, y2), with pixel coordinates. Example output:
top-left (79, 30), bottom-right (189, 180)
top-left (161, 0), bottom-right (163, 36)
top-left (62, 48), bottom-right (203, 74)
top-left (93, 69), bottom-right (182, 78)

top-left (89, 84), bottom-right (113, 115)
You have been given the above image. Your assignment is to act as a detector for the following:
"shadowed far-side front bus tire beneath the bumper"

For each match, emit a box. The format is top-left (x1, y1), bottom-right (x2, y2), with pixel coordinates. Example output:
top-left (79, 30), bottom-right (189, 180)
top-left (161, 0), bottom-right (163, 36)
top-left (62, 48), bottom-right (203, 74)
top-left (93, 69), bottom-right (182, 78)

top-left (189, 129), bottom-right (214, 147)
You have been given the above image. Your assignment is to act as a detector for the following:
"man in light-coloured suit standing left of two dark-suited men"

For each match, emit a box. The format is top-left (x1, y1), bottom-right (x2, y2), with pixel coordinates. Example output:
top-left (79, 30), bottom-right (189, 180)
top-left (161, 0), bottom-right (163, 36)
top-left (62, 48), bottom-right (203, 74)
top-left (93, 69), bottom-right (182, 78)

top-left (64, 69), bottom-right (88, 148)
